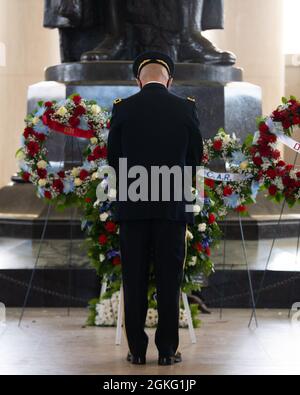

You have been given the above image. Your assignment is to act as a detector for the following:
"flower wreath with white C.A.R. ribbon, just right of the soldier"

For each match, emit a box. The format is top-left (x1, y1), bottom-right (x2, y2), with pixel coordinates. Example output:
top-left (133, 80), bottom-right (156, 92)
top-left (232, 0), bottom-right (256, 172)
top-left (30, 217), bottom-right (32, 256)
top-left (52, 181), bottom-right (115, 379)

top-left (203, 129), bottom-right (260, 217)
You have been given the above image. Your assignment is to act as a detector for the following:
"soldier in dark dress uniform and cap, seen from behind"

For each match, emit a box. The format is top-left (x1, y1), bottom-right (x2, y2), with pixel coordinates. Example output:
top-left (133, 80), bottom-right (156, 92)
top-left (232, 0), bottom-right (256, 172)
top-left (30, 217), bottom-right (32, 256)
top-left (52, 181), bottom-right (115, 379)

top-left (108, 52), bottom-right (203, 365)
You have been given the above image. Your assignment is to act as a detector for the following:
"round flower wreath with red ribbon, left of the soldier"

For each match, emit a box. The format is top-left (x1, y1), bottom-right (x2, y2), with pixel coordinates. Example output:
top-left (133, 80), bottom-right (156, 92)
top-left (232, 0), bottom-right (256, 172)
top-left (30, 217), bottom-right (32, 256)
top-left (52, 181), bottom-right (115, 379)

top-left (16, 94), bottom-right (110, 204)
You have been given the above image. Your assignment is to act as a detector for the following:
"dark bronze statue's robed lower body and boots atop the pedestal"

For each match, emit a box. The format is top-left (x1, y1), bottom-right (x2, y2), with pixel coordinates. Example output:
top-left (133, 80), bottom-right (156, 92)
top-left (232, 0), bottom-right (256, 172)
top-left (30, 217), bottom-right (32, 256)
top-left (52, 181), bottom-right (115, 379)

top-left (44, 0), bottom-right (236, 65)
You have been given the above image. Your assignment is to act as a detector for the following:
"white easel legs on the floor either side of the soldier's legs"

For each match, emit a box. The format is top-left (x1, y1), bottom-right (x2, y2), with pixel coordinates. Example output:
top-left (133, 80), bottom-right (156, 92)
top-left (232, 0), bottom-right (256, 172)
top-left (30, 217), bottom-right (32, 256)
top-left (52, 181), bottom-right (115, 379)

top-left (100, 281), bottom-right (197, 346)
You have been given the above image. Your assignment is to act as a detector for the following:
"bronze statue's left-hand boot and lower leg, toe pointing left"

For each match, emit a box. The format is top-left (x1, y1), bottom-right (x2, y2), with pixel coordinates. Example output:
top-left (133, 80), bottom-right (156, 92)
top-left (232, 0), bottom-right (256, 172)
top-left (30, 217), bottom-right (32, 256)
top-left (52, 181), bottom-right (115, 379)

top-left (81, 0), bottom-right (126, 61)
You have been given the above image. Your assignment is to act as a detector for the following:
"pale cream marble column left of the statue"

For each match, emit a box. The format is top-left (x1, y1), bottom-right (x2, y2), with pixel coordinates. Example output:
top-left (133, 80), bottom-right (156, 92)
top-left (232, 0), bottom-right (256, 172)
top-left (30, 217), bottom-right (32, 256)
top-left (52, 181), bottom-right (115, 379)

top-left (0, 0), bottom-right (59, 187)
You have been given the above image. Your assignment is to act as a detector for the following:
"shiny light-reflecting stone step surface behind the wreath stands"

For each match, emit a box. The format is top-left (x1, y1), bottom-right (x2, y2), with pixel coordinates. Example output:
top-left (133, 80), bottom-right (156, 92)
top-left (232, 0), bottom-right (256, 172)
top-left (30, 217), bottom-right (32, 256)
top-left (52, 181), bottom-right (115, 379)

top-left (0, 238), bottom-right (300, 271)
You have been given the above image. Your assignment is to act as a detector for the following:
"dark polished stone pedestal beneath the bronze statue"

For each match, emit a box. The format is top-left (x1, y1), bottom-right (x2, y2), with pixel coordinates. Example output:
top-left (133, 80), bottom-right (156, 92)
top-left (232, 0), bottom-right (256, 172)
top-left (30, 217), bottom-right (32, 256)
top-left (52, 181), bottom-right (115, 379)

top-left (41, 61), bottom-right (262, 143)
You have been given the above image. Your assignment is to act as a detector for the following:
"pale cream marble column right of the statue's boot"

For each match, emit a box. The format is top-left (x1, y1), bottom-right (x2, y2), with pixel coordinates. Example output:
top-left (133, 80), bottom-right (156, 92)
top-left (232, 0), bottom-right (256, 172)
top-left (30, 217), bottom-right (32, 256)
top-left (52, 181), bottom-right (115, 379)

top-left (206, 0), bottom-right (285, 114)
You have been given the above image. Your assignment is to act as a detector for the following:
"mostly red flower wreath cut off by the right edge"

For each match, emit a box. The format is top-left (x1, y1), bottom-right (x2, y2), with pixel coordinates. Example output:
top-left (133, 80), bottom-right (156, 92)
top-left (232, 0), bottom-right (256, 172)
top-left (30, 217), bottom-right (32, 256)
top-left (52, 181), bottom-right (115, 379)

top-left (250, 97), bottom-right (300, 206)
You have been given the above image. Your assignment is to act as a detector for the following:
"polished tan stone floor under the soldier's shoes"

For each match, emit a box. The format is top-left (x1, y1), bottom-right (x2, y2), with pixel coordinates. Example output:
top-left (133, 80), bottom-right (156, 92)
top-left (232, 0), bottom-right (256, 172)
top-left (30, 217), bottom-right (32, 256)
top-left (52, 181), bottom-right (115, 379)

top-left (0, 309), bottom-right (300, 375)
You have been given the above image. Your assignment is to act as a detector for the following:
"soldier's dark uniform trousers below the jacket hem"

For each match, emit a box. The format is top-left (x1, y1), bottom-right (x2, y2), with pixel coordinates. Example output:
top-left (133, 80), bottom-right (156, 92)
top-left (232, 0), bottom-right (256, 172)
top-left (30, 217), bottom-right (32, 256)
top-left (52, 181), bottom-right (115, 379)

top-left (120, 219), bottom-right (186, 357)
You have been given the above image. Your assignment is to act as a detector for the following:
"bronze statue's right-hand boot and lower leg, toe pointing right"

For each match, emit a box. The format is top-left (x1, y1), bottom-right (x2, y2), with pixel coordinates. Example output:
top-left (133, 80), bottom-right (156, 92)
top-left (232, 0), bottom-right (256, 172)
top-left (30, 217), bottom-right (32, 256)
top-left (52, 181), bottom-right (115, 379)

top-left (178, 0), bottom-right (236, 65)
